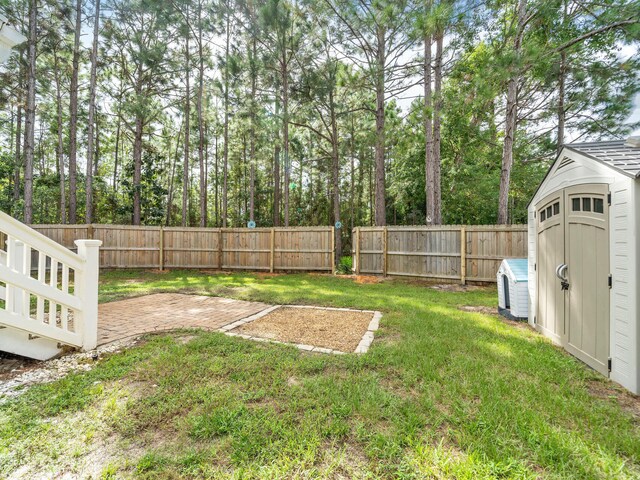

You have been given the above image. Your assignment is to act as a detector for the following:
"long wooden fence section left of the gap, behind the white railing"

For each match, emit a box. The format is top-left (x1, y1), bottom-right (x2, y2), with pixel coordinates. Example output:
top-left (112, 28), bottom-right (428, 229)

top-left (27, 225), bottom-right (335, 272)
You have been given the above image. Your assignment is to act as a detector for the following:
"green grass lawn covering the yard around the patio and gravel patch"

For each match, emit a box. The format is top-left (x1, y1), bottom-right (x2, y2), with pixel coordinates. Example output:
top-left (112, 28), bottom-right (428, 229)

top-left (0, 271), bottom-right (640, 479)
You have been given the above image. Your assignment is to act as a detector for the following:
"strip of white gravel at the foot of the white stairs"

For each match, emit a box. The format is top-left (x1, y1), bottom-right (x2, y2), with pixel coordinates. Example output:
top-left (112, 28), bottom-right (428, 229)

top-left (0, 337), bottom-right (138, 404)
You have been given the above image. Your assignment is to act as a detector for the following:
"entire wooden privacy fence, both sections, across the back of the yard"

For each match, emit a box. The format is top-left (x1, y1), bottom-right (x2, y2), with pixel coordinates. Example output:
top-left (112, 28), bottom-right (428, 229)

top-left (0, 225), bottom-right (527, 283)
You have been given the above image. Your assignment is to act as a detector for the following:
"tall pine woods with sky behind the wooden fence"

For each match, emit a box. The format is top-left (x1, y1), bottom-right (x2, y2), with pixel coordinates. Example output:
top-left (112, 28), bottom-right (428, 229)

top-left (0, 0), bottom-right (640, 236)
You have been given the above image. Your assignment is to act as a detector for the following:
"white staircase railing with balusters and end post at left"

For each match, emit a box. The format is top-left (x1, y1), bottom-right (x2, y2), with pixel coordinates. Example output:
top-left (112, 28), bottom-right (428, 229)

top-left (0, 212), bottom-right (102, 360)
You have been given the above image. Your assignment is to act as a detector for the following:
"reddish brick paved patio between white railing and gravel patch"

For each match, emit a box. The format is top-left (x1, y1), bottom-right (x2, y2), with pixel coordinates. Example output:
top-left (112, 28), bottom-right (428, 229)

top-left (98, 293), bottom-right (269, 345)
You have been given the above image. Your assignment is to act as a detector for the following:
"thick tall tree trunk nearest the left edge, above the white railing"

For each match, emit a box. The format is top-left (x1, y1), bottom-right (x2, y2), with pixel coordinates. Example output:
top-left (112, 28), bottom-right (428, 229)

top-left (24, 0), bottom-right (38, 224)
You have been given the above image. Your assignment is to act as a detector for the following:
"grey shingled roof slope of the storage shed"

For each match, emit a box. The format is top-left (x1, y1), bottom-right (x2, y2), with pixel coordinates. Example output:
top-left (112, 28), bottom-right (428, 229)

top-left (564, 140), bottom-right (640, 178)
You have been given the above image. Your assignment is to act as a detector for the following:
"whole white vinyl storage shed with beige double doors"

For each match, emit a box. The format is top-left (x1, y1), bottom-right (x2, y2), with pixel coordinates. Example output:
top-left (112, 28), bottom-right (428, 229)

top-left (528, 138), bottom-right (640, 394)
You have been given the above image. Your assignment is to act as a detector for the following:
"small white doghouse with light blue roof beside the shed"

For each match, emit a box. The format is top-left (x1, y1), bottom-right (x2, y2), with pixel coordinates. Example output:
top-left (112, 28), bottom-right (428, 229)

top-left (497, 258), bottom-right (529, 320)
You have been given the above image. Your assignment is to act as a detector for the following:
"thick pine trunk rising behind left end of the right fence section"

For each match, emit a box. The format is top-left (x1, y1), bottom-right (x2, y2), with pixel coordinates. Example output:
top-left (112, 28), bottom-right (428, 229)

top-left (375, 26), bottom-right (387, 227)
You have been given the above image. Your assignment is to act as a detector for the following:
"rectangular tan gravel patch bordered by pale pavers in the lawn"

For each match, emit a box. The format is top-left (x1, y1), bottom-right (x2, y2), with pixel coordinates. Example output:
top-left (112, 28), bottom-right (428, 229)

top-left (234, 307), bottom-right (373, 352)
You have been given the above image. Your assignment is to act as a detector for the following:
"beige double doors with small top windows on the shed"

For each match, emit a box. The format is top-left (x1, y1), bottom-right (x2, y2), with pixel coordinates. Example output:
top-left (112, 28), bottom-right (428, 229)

top-left (536, 184), bottom-right (609, 375)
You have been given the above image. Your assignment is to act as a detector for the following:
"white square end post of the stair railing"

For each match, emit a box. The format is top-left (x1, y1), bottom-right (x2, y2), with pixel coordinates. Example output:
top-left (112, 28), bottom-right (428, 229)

top-left (74, 240), bottom-right (102, 350)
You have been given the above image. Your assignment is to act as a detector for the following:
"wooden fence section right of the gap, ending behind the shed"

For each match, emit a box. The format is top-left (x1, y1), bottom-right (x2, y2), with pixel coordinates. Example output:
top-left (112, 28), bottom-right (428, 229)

top-left (352, 225), bottom-right (527, 283)
